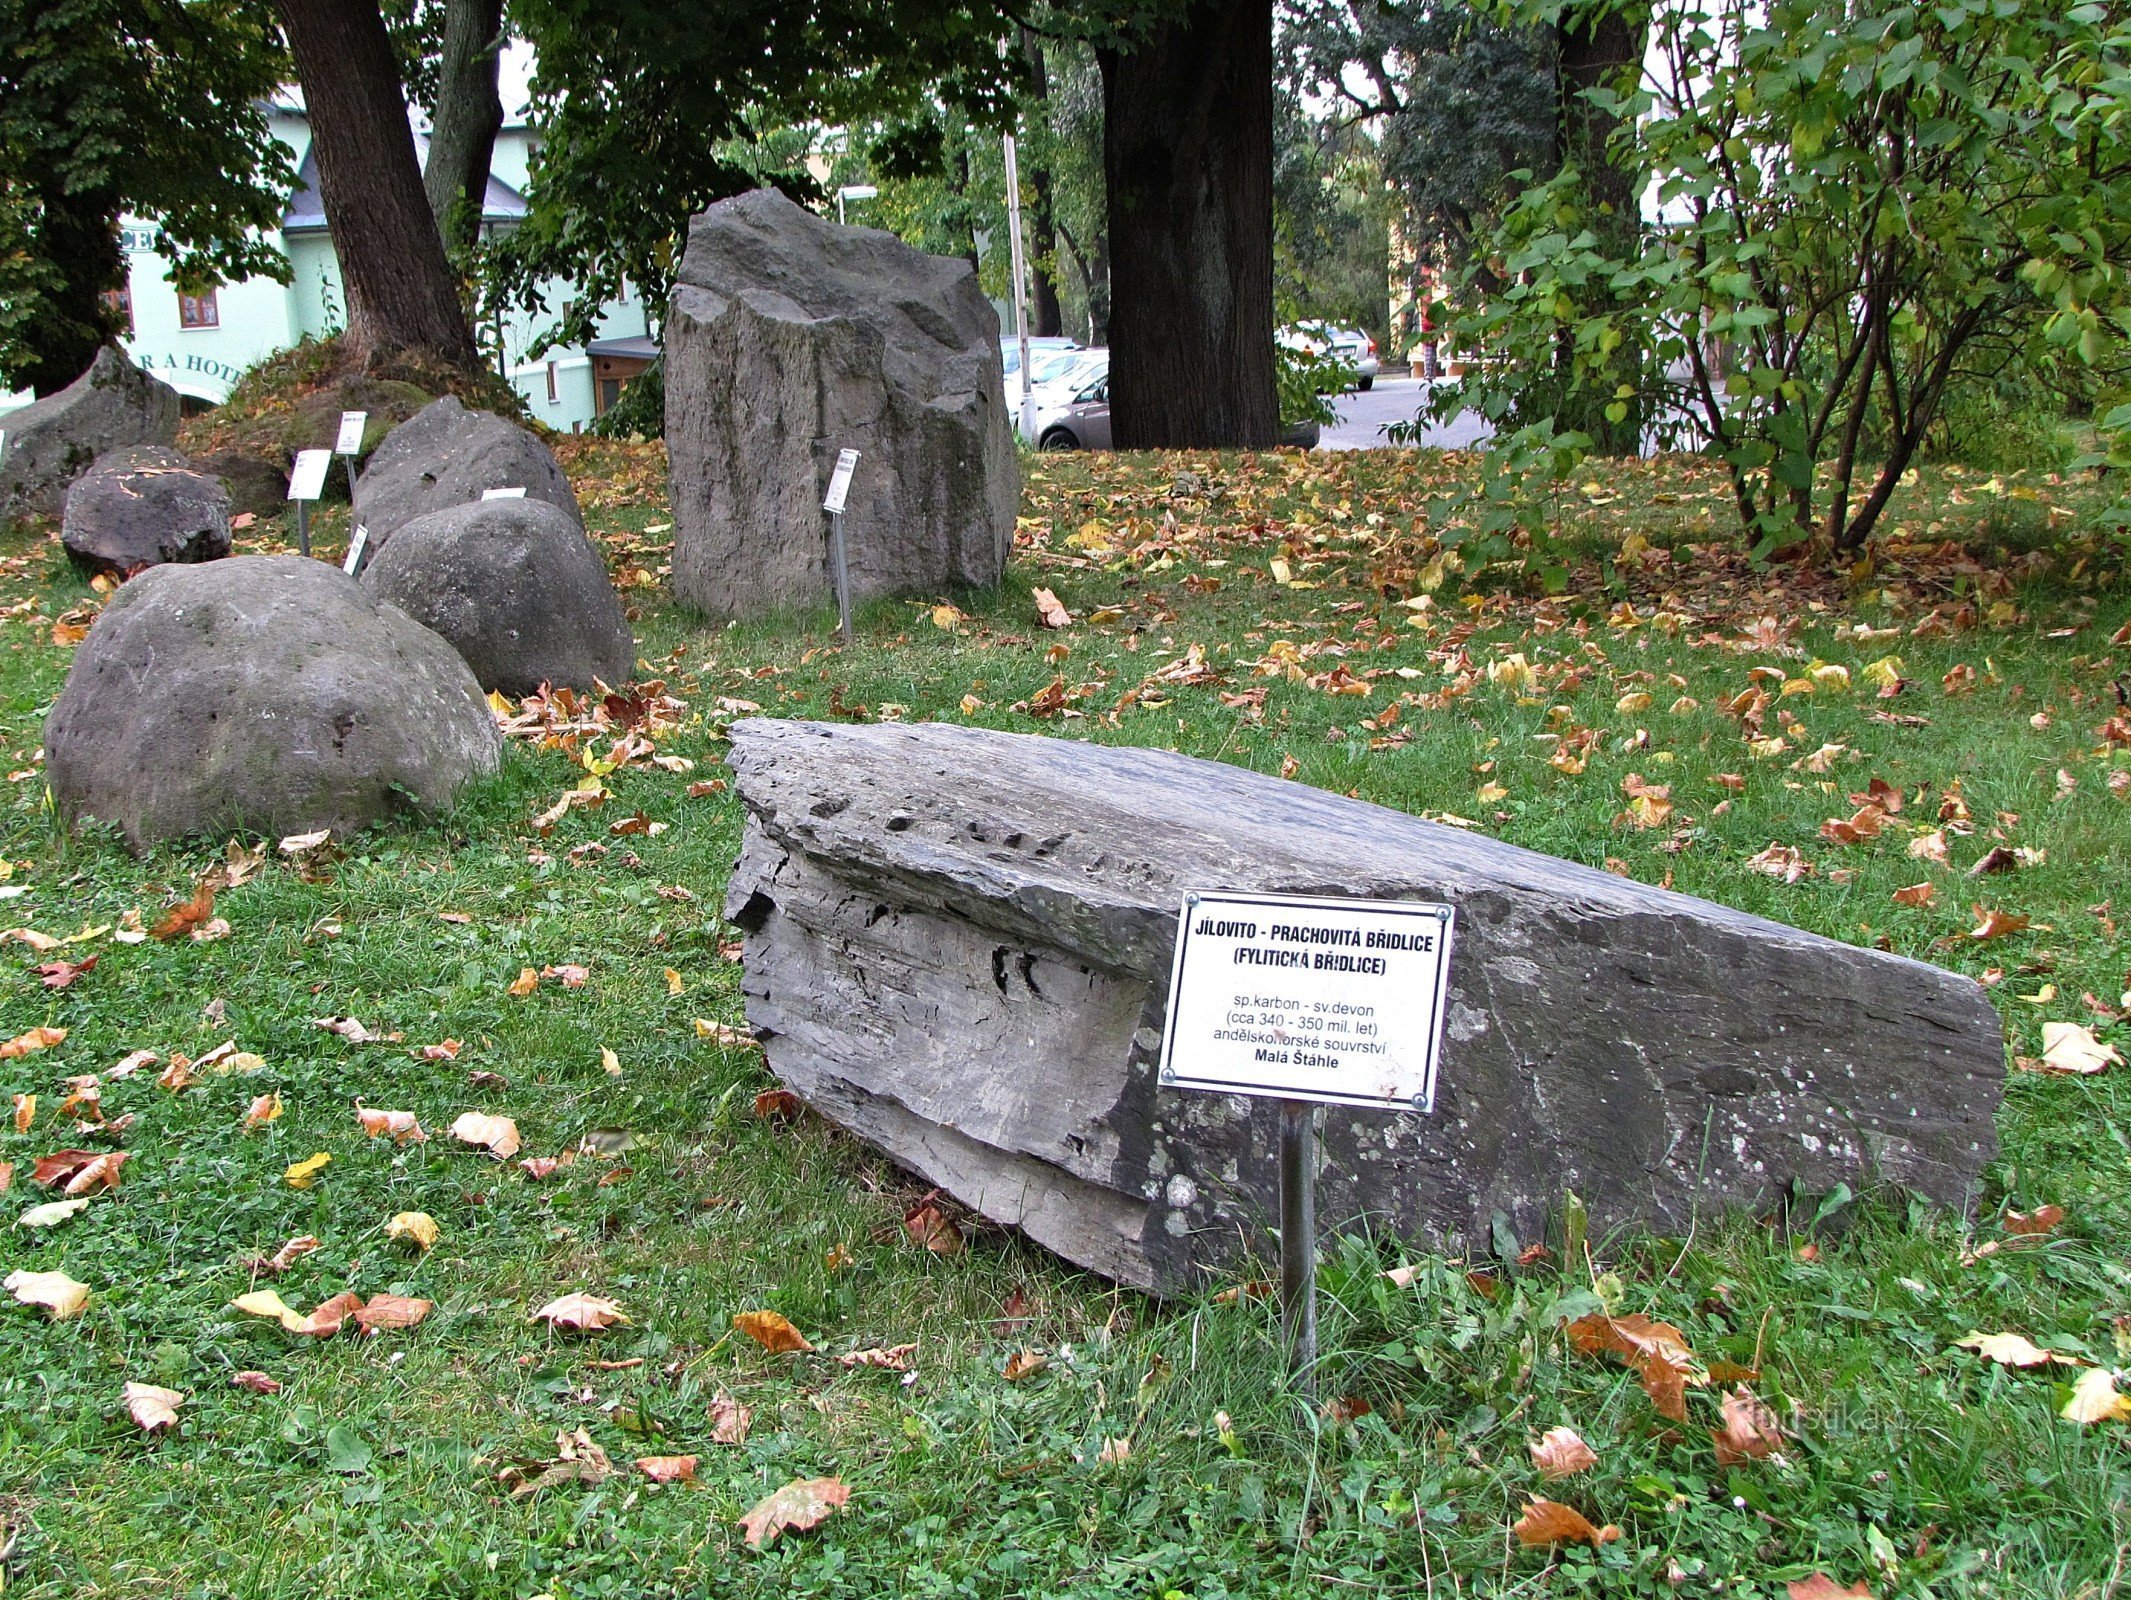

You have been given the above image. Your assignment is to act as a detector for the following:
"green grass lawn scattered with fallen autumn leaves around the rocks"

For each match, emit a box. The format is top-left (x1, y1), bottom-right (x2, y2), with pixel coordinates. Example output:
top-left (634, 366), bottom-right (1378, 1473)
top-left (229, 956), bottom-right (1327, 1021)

top-left (0, 441), bottom-right (2131, 1600)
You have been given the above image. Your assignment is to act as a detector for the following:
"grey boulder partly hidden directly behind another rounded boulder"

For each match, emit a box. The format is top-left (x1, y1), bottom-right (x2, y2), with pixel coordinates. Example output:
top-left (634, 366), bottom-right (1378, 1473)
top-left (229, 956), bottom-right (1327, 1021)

top-left (356, 394), bottom-right (584, 550)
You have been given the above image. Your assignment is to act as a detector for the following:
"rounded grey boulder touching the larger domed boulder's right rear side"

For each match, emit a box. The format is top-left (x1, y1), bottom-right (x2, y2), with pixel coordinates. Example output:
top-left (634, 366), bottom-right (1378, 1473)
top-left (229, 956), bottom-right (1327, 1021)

top-left (362, 501), bottom-right (637, 695)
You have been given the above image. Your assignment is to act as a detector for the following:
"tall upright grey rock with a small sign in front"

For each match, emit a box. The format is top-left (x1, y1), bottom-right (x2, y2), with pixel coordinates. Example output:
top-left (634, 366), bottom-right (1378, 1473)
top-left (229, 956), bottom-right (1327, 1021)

top-left (665, 190), bottom-right (1021, 618)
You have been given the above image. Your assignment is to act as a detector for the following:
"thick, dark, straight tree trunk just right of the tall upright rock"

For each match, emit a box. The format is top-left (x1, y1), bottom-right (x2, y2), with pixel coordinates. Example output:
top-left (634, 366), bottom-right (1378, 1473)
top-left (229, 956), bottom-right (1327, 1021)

top-left (1097, 0), bottom-right (1281, 450)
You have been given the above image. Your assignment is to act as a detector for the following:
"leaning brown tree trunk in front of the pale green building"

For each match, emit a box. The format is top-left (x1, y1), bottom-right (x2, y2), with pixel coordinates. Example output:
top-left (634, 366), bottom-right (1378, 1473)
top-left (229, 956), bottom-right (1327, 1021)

top-left (277, 0), bottom-right (479, 371)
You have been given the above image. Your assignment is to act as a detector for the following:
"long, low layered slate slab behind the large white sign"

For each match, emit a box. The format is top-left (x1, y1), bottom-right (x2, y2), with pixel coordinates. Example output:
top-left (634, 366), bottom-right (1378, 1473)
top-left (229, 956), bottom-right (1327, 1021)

top-left (727, 720), bottom-right (2003, 1291)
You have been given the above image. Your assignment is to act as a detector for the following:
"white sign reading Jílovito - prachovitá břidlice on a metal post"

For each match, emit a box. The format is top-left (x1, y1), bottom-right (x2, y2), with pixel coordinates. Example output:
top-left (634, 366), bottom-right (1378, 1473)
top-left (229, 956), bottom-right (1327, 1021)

top-left (1161, 893), bottom-right (1455, 1112)
